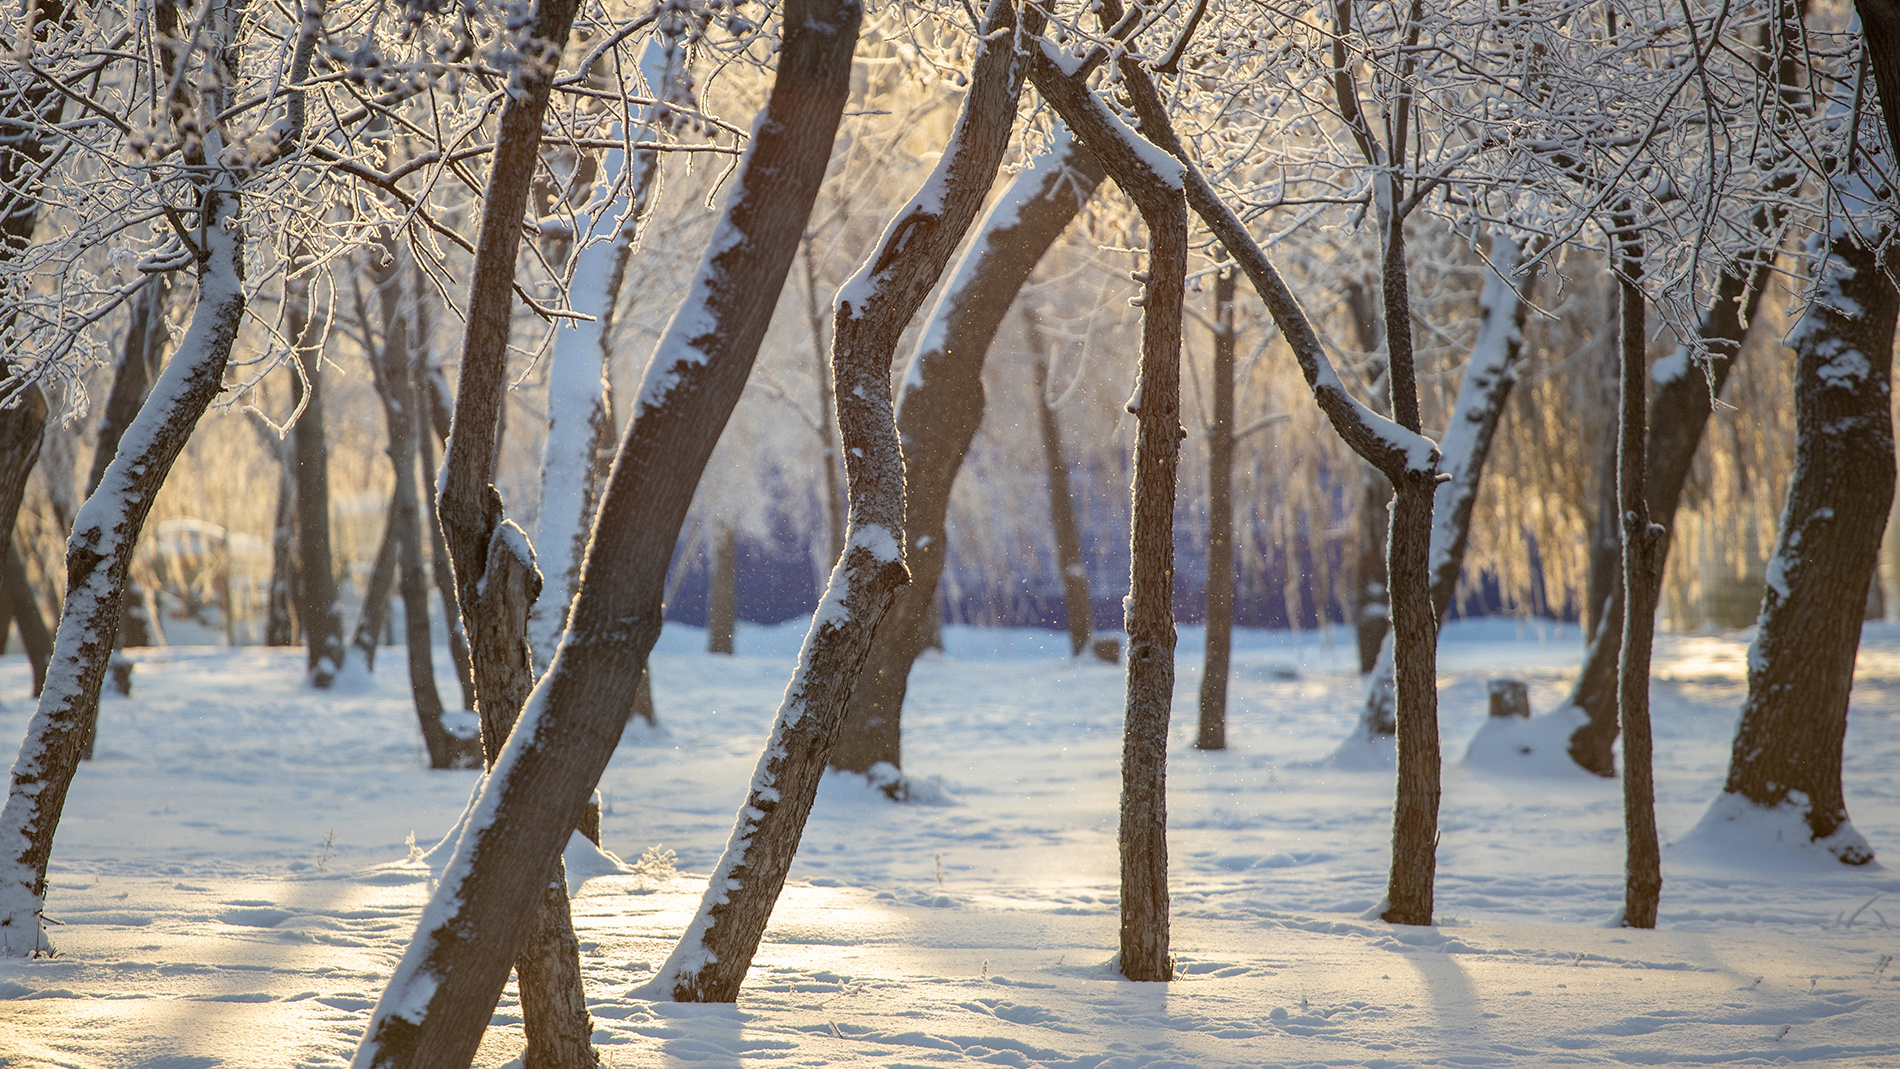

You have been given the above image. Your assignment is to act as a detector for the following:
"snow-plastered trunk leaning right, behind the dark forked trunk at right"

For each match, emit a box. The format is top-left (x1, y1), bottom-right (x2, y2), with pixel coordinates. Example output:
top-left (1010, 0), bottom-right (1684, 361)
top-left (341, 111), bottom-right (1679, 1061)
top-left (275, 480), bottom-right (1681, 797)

top-left (1359, 234), bottom-right (1531, 739)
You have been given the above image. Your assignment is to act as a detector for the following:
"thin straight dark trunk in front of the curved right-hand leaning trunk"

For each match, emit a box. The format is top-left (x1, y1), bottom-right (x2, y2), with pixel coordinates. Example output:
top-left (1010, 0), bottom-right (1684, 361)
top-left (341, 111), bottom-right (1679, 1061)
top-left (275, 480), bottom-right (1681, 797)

top-left (1615, 218), bottom-right (1664, 928)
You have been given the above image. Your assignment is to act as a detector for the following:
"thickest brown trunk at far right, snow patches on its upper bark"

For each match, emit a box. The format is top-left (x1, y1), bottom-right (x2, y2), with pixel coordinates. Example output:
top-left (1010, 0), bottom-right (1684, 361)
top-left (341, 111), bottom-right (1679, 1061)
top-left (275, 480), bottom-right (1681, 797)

top-left (1704, 177), bottom-right (1900, 864)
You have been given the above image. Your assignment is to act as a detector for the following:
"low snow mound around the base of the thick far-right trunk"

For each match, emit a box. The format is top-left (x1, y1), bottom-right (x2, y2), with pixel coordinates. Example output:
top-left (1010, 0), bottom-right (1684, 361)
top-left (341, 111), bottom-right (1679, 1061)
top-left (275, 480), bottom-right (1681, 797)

top-left (1668, 790), bottom-right (1881, 873)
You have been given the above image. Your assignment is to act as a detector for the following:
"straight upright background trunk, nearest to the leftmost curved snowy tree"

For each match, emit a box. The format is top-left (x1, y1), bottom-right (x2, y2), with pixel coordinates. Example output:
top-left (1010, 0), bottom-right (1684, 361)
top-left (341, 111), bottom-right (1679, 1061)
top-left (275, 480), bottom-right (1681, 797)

top-left (285, 263), bottom-right (344, 687)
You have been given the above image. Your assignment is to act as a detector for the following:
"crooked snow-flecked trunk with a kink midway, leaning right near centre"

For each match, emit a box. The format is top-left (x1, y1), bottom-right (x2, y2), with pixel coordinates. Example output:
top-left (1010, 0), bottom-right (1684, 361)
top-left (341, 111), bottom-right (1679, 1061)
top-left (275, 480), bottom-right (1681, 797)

top-left (646, 0), bottom-right (1043, 1003)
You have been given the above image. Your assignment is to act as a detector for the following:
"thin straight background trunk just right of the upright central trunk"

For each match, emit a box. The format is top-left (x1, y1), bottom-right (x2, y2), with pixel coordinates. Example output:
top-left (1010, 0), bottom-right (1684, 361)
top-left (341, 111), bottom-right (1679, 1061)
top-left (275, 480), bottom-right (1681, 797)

top-left (1193, 268), bottom-right (1235, 750)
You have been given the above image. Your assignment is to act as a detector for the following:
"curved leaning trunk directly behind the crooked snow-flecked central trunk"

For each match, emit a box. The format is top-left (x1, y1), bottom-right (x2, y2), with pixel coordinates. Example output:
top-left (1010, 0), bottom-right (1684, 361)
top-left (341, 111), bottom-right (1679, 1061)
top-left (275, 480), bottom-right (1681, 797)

top-left (832, 127), bottom-right (1102, 778)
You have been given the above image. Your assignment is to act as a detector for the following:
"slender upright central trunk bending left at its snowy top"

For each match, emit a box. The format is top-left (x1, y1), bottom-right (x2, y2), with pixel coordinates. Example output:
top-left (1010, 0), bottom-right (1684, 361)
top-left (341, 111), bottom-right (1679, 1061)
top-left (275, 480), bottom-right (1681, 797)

top-left (1030, 29), bottom-right (1188, 982)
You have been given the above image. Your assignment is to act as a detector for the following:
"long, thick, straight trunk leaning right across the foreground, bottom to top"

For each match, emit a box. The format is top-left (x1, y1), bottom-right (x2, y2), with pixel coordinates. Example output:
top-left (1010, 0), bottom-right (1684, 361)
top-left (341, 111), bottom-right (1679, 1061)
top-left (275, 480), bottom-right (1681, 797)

top-left (355, 0), bottom-right (863, 1069)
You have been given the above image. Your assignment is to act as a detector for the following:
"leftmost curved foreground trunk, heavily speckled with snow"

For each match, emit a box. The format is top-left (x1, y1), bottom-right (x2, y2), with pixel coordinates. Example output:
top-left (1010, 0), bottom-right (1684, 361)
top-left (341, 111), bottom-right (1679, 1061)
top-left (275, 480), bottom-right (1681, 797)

top-left (0, 171), bottom-right (245, 957)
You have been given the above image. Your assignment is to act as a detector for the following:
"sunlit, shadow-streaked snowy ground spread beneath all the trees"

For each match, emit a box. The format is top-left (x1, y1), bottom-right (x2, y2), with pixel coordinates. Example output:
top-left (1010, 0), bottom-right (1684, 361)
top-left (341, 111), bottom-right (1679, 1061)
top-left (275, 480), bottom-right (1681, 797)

top-left (0, 621), bottom-right (1900, 1069)
